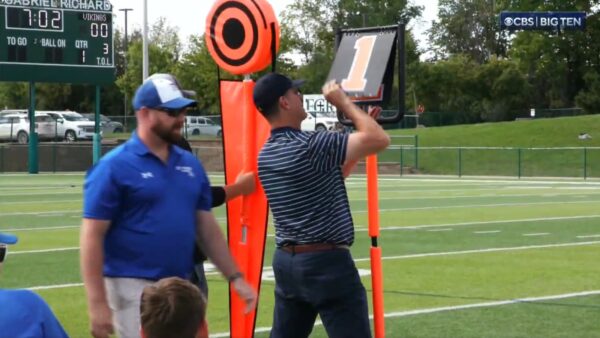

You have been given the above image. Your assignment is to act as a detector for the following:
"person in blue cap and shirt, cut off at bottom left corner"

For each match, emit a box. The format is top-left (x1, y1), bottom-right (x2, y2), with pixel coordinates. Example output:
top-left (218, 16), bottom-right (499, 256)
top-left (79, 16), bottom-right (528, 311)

top-left (0, 233), bottom-right (68, 338)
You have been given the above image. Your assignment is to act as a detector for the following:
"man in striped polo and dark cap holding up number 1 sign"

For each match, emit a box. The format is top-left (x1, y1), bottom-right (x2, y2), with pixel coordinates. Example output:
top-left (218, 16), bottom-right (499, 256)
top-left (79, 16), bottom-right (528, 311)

top-left (253, 73), bottom-right (390, 338)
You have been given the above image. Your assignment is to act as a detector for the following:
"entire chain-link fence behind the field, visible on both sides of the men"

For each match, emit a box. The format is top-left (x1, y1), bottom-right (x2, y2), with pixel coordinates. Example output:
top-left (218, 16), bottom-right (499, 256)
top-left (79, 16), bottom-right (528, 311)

top-left (0, 139), bottom-right (600, 179)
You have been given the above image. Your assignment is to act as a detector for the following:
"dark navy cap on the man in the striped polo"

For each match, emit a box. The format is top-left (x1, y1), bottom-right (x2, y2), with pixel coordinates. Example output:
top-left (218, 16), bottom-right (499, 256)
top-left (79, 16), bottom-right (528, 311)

top-left (252, 73), bottom-right (305, 112)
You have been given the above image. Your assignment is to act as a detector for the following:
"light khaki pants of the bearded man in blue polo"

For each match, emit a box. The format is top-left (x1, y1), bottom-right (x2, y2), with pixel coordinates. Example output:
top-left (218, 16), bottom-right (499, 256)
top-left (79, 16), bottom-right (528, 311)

top-left (104, 277), bottom-right (154, 338)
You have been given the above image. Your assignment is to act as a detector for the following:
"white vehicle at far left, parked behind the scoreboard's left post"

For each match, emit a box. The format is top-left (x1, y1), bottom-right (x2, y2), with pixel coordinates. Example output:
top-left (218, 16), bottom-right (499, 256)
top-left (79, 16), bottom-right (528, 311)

top-left (0, 114), bottom-right (56, 144)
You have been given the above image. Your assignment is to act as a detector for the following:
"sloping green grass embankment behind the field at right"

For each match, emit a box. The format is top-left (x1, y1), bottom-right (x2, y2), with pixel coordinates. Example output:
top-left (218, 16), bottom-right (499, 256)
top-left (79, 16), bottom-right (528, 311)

top-left (380, 115), bottom-right (600, 177)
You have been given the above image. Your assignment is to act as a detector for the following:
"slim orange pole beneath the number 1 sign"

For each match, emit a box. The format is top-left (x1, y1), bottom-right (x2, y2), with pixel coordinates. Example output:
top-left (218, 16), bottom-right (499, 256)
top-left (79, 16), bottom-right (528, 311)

top-left (367, 155), bottom-right (385, 338)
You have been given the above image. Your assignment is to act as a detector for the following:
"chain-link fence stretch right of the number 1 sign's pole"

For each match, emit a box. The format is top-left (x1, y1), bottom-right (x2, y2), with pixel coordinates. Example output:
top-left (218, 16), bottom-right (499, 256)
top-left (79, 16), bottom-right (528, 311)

top-left (379, 145), bottom-right (600, 179)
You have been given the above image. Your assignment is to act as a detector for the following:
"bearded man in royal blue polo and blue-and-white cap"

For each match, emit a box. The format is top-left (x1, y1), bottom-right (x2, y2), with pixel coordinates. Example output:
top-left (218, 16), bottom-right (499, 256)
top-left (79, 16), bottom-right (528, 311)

top-left (81, 77), bottom-right (256, 338)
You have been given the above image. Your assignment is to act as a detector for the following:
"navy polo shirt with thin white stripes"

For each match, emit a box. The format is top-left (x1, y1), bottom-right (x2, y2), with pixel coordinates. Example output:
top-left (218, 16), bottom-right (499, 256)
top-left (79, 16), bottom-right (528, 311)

top-left (258, 128), bottom-right (354, 246)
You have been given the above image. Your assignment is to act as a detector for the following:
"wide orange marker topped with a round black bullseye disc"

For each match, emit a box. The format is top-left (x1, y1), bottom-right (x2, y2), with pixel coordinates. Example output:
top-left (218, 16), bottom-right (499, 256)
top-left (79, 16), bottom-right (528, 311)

top-left (205, 0), bottom-right (279, 338)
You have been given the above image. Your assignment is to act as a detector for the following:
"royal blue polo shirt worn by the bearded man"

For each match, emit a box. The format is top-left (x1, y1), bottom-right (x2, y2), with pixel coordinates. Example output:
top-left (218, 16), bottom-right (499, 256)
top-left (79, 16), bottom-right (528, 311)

top-left (83, 132), bottom-right (211, 280)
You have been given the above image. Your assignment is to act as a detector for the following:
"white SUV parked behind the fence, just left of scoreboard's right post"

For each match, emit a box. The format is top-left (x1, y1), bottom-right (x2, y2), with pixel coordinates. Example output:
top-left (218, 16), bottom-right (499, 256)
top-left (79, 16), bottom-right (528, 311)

top-left (35, 111), bottom-right (102, 142)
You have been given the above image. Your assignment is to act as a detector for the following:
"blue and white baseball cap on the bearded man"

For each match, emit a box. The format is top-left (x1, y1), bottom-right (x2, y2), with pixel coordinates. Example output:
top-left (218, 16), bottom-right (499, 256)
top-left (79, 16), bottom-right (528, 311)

top-left (132, 75), bottom-right (198, 110)
